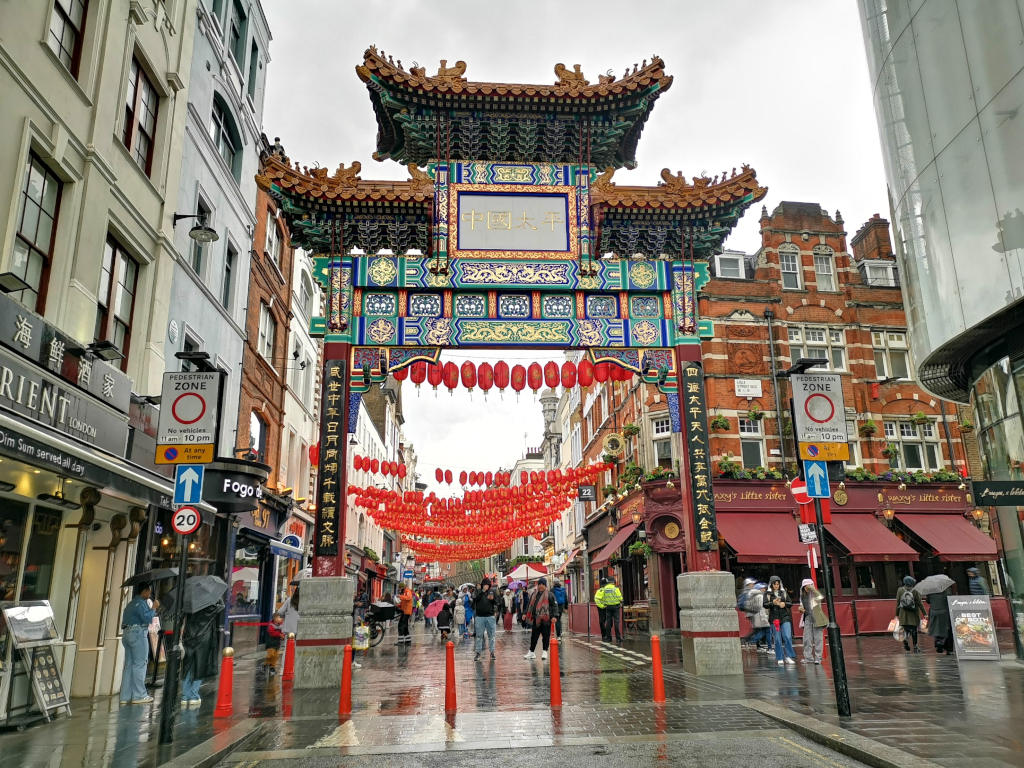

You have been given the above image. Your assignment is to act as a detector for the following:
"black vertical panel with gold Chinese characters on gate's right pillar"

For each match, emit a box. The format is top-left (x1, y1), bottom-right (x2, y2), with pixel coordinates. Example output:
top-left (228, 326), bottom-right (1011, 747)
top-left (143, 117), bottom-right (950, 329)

top-left (680, 362), bottom-right (718, 550)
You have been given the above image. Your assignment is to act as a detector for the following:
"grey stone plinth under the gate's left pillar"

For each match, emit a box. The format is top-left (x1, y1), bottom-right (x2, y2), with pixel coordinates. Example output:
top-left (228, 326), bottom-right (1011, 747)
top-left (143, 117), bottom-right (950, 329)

top-left (294, 577), bottom-right (355, 688)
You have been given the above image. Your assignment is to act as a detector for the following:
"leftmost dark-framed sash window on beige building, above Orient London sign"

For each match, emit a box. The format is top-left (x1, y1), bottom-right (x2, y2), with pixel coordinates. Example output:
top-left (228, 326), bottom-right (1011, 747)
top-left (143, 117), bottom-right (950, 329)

top-left (10, 153), bottom-right (63, 313)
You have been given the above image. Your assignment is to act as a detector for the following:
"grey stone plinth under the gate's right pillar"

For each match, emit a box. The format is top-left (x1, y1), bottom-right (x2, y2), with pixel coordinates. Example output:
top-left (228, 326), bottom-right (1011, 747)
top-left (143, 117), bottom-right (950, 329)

top-left (676, 570), bottom-right (743, 675)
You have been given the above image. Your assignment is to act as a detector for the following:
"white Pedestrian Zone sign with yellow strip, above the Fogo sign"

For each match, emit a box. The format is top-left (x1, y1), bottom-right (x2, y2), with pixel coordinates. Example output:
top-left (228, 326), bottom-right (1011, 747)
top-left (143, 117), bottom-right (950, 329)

top-left (156, 371), bottom-right (221, 464)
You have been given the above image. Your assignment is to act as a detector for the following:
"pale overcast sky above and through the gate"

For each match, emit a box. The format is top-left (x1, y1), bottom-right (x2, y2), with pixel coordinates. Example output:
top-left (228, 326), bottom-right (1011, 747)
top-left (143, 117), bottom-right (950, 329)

top-left (263, 0), bottom-right (888, 493)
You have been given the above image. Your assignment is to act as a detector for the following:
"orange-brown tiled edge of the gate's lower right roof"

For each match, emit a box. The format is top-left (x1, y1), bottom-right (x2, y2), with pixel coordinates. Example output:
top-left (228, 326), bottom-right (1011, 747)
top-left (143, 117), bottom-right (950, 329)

top-left (590, 165), bottom-right (768, 209)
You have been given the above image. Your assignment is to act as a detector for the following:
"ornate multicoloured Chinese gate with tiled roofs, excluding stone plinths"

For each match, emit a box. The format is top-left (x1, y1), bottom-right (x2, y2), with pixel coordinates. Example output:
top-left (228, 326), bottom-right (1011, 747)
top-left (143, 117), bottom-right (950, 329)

top-left (258, 48), bottom-right (766, 671)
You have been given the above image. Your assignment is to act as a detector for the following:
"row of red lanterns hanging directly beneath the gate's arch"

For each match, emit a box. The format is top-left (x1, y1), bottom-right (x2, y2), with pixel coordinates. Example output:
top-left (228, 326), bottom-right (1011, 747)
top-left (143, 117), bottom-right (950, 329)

top-left (392, 359), bottom-right (635, 394)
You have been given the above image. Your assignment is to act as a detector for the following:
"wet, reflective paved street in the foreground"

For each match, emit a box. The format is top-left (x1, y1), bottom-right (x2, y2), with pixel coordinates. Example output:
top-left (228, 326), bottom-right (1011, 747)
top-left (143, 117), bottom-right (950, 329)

top-left (0, 624), bottom-right (1024, 768)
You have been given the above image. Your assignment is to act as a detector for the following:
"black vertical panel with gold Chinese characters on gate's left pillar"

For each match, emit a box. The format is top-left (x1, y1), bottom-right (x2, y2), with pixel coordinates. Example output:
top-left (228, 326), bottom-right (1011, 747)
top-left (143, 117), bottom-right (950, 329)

top-left (313, 360), bottom-right (348, 557)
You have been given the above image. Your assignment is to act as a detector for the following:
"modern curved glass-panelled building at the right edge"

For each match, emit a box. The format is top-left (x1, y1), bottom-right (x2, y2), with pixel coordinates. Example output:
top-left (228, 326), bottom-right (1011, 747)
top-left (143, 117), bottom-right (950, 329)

top-left (859, 0), bottom-right (1024, 651)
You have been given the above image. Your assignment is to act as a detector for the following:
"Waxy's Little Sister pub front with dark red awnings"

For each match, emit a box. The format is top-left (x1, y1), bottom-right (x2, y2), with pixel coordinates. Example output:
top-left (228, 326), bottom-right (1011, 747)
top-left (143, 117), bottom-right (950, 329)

top-left (715, 478), bottom-right (1010, 635)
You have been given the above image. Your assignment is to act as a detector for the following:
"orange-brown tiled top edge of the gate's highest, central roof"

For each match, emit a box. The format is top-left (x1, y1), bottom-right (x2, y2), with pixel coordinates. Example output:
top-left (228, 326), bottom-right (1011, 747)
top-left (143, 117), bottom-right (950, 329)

top-left (355, 46), bottom-right (672, 99)
